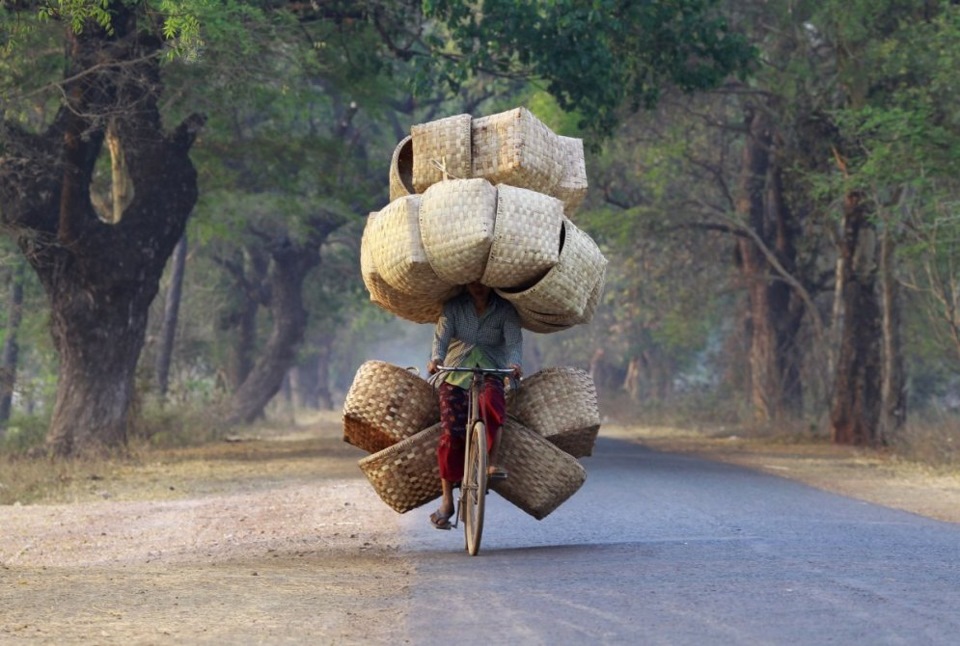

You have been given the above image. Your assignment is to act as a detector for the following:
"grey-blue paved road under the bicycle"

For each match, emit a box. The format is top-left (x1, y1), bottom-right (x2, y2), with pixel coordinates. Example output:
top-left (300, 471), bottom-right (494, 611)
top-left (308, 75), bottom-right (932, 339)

top-left (396, 438), bottom-right (960, 646)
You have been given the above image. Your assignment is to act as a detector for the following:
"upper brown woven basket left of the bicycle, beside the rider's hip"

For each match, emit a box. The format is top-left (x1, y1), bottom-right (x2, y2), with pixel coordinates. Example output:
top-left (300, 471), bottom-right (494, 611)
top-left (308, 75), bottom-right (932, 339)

top-left (343, 361), bottom-right (440, 453)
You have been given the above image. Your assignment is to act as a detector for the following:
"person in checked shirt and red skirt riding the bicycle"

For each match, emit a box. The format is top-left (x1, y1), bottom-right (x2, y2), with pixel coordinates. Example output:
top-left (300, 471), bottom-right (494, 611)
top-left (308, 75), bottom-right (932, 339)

top-left (427, 282), bottom-right (523, 529)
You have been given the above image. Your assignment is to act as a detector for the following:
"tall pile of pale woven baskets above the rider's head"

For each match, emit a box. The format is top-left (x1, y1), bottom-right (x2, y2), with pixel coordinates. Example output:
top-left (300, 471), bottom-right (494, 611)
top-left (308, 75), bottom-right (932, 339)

top-left (360, 108), bottom-right (607, 333)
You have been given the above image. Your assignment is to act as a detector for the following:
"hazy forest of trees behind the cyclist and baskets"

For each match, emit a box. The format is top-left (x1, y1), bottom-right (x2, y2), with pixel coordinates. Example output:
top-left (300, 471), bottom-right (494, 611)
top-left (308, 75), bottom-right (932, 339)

top-left (0, 0), bottom-right (960, 474)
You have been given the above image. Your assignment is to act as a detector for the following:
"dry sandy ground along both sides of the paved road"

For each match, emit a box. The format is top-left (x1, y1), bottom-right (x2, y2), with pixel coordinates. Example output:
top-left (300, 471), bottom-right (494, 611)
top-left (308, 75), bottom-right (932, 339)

top-left (0, 415), bottom-right (960, 645)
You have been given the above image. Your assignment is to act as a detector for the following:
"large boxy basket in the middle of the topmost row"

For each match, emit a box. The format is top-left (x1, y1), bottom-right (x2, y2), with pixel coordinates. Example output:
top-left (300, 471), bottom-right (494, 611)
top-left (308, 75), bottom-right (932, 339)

top-left (471, 108), bottom-right (566, 195)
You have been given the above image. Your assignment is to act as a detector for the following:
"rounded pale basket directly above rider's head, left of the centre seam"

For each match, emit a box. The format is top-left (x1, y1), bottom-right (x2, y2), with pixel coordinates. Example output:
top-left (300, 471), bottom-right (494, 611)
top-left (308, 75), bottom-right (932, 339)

top-left (420, 179), bottom-right (497, 285)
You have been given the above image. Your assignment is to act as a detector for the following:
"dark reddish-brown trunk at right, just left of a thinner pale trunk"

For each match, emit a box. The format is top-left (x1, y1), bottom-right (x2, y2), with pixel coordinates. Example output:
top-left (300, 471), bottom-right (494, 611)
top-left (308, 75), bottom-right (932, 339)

top-left (830, 192), bottom-right (883, 446)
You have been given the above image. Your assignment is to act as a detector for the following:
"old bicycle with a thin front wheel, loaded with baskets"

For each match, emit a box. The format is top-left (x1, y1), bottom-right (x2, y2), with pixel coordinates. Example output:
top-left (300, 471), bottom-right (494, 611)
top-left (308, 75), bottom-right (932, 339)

top-left (436, 366), bottom-right (513, 556)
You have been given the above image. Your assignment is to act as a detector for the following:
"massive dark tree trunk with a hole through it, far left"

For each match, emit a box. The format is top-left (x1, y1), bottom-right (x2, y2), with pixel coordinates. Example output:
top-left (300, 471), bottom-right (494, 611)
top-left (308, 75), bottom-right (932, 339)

top-left (0, 8), bottom-right (203, 455)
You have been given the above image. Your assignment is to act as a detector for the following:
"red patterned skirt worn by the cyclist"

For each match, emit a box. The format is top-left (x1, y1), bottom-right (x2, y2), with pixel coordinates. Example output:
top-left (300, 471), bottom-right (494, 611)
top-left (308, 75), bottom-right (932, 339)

top-left (437, 375), bottom-right (507, 482)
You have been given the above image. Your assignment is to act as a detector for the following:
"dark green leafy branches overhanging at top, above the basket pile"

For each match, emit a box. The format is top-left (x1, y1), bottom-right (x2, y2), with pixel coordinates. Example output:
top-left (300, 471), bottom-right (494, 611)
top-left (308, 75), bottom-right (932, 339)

top-left (421, 0), bottom-right (754, 135)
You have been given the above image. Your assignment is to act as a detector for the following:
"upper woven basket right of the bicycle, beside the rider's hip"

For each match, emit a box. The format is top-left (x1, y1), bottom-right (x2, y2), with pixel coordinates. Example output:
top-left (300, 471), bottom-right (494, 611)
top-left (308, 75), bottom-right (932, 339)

top-left (507, 367), bottom-right (600, 458)
